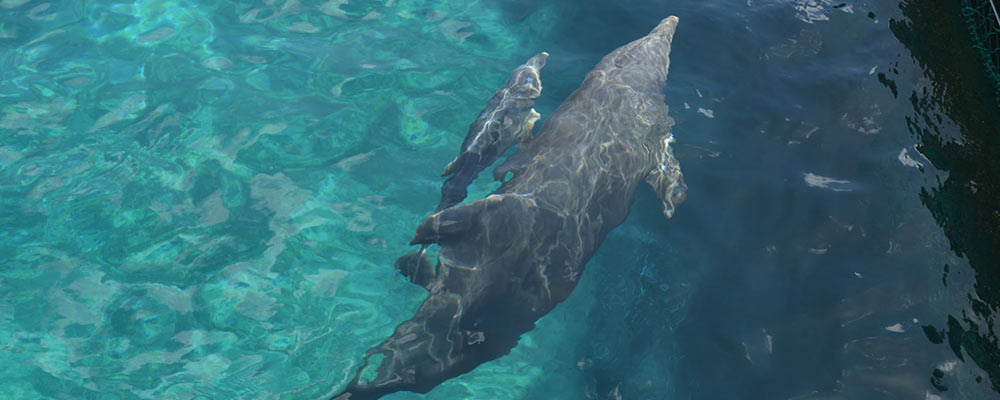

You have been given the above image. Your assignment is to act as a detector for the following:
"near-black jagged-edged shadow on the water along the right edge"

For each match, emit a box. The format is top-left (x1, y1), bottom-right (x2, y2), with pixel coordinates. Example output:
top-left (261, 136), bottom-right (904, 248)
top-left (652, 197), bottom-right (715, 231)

top-left (886, 0), bottom-right (1000, 392)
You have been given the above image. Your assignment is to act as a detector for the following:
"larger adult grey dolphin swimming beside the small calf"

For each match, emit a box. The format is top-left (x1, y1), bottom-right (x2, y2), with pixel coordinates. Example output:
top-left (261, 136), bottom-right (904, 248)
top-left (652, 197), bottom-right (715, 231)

top-left (334, 17), bottom-right (686, 400)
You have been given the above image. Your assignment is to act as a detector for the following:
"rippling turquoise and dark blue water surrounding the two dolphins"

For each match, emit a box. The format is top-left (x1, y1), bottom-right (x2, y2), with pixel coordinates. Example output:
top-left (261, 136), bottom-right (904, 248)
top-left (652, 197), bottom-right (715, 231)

top-left (0, 0), bottom-right (1000, 399)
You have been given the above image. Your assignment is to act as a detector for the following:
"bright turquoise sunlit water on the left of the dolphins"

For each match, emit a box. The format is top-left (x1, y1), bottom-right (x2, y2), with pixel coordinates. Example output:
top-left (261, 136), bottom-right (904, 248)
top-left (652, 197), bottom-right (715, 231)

top-left (0, 1), bottom-right (576, 398)
